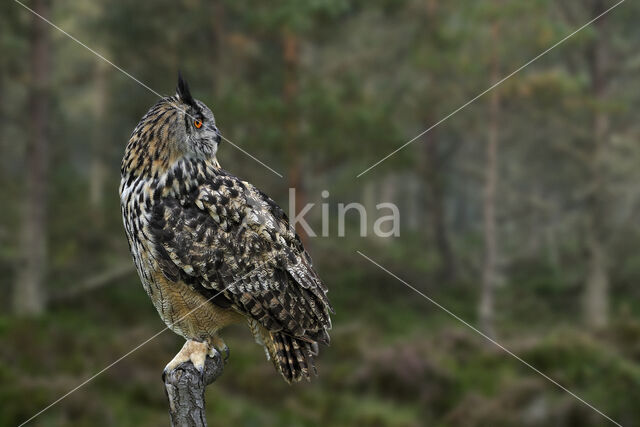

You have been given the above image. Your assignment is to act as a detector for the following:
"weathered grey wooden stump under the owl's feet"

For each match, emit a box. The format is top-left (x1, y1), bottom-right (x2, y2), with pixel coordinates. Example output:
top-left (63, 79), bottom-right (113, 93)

top-left (163, 352), bottom-right (224, 427)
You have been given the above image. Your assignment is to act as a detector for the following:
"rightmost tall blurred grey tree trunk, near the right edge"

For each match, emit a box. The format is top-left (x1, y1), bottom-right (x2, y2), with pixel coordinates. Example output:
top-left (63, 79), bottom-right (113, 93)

top-left (584, 0), bottom-right (609, 328)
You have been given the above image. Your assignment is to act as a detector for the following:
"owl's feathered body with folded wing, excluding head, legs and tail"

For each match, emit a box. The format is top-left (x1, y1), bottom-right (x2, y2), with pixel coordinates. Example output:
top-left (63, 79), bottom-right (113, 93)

top-left (121, 158), bottom-right (332, 352)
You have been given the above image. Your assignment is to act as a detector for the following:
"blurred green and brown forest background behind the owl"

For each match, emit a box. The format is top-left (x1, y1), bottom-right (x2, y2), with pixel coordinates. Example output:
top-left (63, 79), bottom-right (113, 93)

top-left (0, 0), bottom-right (640, 426)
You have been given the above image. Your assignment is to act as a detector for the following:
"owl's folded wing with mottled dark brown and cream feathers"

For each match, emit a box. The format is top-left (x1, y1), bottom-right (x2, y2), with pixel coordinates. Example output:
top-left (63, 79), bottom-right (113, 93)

top-left (149, 172), bottom-right (333, 343)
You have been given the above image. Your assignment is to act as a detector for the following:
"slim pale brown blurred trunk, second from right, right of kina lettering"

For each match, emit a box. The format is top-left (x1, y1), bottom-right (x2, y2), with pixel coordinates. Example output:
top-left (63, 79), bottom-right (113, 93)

top-left (479, 24), bottom-right (500, 336)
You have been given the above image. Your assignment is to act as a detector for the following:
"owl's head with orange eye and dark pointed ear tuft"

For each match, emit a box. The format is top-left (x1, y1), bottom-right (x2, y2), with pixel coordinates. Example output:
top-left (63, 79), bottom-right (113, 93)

top-left (122, 74), bottom-right (222, 177)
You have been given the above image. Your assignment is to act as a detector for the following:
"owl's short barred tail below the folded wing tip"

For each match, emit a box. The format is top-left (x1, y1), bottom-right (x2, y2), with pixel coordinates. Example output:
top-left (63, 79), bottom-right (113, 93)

top-left (250, 322), bottom-right (318, 384)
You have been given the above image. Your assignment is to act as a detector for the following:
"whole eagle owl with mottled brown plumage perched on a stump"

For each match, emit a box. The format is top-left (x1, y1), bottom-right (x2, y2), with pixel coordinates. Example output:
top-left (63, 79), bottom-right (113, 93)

top-left (120, 76), bottom-right (333, 383)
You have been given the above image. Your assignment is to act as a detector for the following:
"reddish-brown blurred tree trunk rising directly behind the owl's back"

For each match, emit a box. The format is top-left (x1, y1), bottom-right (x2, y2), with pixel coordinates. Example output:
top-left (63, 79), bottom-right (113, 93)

top-left (282, 29), bottom-right (307, 244)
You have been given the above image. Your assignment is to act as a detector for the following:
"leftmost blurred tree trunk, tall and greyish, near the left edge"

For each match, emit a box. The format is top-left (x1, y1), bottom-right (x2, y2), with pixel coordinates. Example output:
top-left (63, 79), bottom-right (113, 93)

top-left (13, 0), bottom-right (50, 315)
